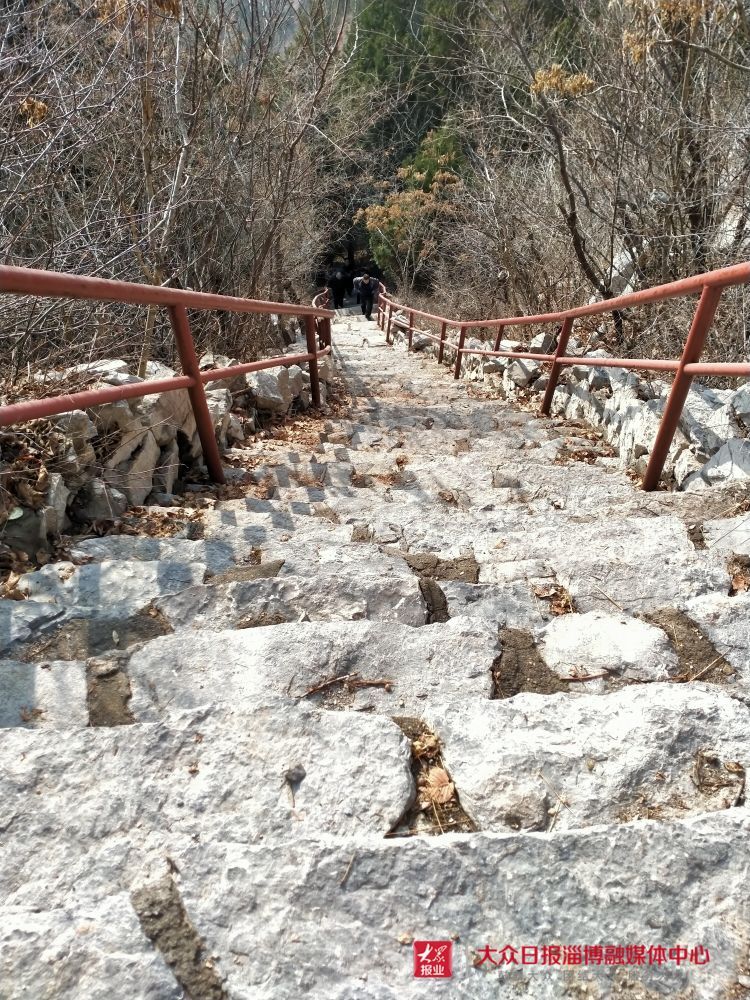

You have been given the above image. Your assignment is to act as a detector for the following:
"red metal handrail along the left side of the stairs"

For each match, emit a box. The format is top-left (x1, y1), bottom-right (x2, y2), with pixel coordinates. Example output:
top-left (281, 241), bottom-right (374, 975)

top-left (0, 265), bottom-right (333, 483)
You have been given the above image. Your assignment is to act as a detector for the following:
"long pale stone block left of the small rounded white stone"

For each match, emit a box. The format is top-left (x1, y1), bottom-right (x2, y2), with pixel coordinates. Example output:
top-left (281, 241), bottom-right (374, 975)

top-left (126, 616), bottom-right (498, 722)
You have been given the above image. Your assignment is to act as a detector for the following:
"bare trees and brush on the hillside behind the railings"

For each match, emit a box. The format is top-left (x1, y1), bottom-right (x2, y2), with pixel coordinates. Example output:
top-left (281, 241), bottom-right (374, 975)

top-left (0, 0), bottom-right (750, 382)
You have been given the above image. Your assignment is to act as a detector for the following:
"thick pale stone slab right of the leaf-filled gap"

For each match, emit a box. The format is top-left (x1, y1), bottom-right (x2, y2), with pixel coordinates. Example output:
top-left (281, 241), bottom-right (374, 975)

top-left (427, 683), bottom-right (750, 832)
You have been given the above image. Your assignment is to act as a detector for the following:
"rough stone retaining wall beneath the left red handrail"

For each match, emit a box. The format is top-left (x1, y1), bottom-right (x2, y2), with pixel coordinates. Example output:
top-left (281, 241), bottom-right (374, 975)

top-left (0, 341), bottom-right (334, 556)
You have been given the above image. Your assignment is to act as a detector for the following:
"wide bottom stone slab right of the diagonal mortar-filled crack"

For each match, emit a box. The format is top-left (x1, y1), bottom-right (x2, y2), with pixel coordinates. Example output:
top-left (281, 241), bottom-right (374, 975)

top-left (160, 820), bottom-right (750, 1000)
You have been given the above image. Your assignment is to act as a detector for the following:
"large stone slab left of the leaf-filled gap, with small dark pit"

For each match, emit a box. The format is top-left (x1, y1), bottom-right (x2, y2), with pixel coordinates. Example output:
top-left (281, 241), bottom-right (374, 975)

top-left (0, 698), bottom-right (414, 912)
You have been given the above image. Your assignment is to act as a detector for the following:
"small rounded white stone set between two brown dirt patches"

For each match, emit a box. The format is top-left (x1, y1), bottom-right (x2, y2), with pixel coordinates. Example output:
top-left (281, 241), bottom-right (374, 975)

top-left (539, 611), bottom-right (679, 681)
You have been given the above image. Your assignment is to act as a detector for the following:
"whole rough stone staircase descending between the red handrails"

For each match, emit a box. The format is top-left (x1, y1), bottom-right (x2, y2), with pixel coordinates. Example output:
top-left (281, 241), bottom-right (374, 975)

top-left (0, 313), bottom-right (750, 1000)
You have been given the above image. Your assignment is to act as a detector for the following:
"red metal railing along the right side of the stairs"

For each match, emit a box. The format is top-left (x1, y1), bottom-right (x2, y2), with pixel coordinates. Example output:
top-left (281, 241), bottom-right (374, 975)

top-left (378, 263), bottom-right (750, 490)
